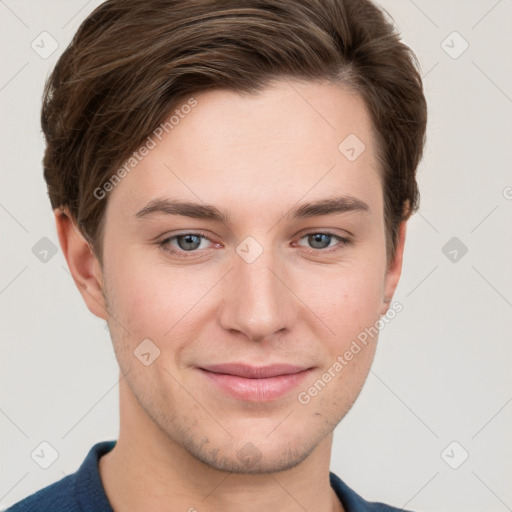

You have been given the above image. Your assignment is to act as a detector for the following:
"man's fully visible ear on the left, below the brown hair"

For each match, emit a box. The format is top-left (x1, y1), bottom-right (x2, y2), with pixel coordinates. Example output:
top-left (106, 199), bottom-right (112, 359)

top-left (54, 208), bottom-right (108, 320)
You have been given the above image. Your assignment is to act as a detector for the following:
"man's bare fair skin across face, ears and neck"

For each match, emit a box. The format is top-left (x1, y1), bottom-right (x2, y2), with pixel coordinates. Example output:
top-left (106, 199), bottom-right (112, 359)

top-left (55, 81), bottom-right (406, 512)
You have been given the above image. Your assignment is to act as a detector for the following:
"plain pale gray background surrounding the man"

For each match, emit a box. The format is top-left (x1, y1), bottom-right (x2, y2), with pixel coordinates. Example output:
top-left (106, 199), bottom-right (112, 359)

top-left (0, 0), bottom-right (512, 512)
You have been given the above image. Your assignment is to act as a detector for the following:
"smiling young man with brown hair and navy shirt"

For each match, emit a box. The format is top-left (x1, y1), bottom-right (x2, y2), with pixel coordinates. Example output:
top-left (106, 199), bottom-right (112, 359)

top-left (10, 0), bottom-right (426, 512)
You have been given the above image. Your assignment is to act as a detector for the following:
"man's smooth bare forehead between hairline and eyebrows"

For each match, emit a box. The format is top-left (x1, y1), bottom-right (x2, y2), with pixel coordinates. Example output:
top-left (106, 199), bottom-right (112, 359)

top-left (108, 80), bottom-right (381, 222)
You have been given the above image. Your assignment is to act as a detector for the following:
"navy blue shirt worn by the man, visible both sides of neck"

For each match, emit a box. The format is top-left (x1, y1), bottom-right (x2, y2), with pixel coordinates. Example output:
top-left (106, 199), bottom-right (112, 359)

top-left (6, 441), bottom-right (412, 512)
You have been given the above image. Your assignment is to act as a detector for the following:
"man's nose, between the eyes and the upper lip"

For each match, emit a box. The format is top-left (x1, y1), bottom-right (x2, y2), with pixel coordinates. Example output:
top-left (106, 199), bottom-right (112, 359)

top-left (220, 242), bottom-right (297, 341)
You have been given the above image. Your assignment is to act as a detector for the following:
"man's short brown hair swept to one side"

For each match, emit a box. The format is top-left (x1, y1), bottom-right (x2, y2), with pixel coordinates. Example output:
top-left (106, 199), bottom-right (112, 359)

top-left (41, 0), bottom-right (427, 262)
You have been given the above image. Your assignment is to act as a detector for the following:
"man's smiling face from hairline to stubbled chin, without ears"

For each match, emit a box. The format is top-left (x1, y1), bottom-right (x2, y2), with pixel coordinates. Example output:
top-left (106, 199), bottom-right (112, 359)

top-left (93, 81), bottom-right (396, 473)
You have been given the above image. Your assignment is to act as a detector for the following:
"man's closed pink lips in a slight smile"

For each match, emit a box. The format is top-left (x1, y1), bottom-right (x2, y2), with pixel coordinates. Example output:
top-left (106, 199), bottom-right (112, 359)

top-left (198, 363), bottom-right (313, 402)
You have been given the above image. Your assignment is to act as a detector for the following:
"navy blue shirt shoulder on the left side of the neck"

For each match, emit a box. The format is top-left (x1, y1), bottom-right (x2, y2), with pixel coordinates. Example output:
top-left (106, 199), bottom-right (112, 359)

top-left (5, 441), bottom-right (115, 512)
